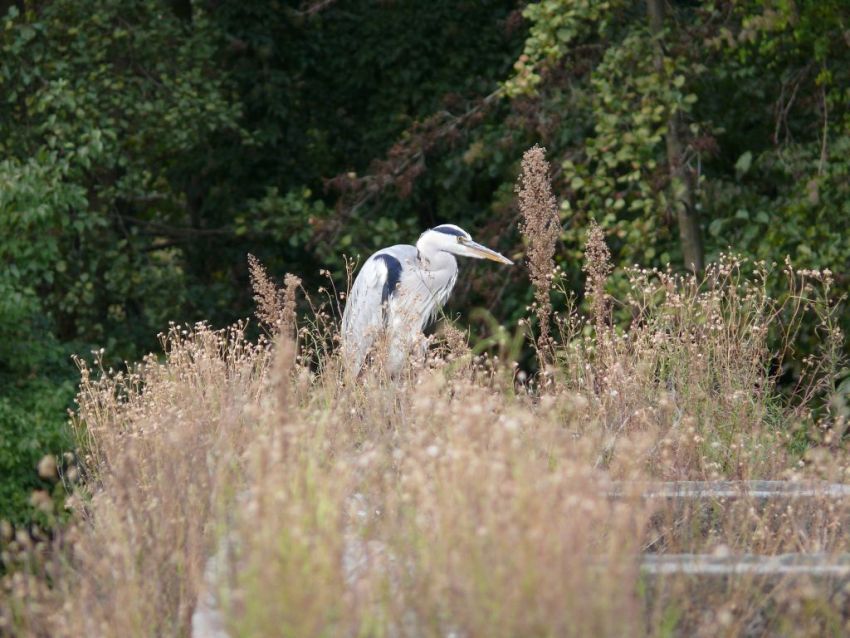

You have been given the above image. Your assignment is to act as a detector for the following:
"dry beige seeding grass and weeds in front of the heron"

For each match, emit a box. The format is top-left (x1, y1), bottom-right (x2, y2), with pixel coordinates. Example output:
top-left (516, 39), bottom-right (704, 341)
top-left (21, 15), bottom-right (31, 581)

top-left (0, 234), bottom-right (850, 637)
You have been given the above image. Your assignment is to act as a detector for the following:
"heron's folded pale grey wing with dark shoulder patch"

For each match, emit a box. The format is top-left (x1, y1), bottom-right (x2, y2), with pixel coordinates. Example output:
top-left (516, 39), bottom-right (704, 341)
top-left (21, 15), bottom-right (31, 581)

top-left (342, 246), bottom-right (408, 372)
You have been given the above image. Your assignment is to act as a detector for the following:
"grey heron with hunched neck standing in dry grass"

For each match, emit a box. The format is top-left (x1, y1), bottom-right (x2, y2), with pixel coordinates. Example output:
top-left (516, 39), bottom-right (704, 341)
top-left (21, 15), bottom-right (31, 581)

top-left (341, 224), bottom-right (513, 374)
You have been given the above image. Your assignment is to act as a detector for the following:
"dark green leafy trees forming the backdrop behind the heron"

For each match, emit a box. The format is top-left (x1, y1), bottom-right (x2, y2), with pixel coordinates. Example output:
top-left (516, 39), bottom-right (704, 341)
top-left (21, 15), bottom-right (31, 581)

top-left (0, 0), bottom-right (850, 522)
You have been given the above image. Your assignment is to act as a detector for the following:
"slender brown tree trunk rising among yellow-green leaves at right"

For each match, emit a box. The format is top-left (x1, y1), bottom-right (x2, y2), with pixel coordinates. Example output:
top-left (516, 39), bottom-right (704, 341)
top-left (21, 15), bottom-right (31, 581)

top-left (646, 0), bottom-right (705, 274)
